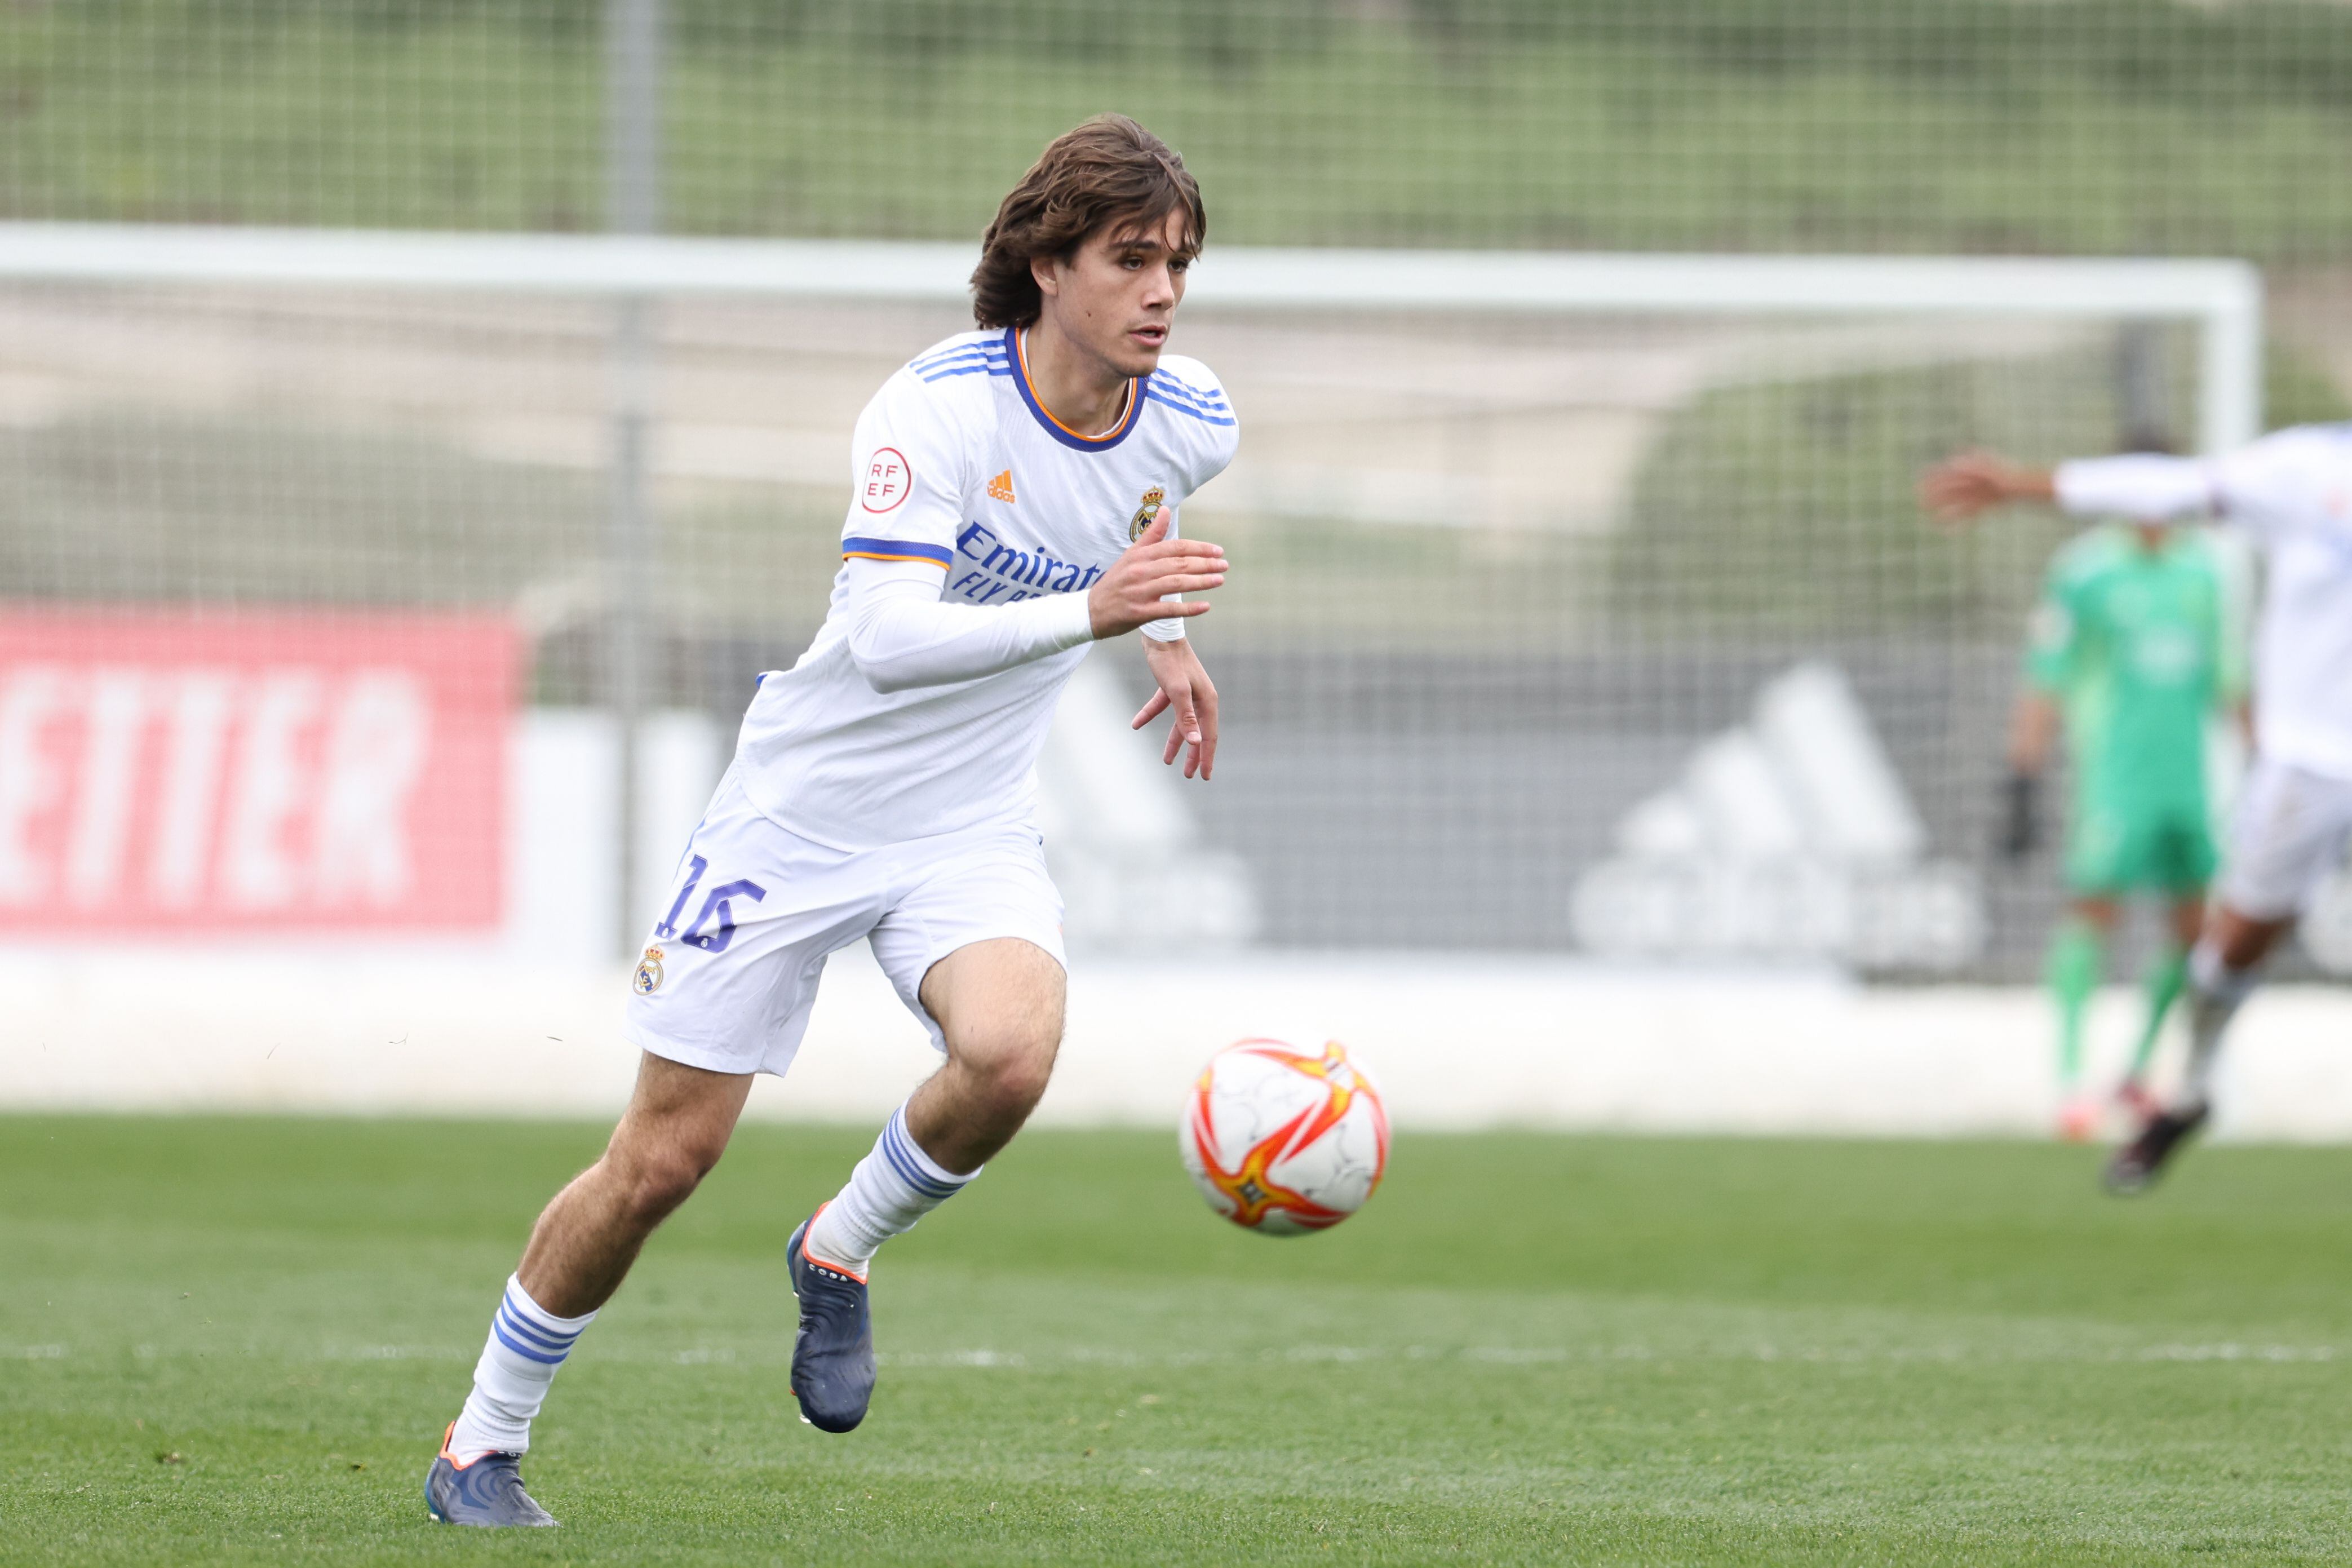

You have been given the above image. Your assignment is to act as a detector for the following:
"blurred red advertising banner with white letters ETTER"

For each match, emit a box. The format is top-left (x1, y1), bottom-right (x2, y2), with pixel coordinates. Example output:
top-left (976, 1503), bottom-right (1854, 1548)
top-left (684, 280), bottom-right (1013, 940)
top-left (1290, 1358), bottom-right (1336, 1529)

top-left (0, 604), bottom-right (517, 936)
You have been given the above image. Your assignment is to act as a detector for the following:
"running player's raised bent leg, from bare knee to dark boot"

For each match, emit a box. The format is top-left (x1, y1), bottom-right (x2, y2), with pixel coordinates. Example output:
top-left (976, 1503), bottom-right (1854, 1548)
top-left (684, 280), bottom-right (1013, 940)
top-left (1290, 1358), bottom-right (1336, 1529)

top-left (790, 938), bottom-right (1068, 1432)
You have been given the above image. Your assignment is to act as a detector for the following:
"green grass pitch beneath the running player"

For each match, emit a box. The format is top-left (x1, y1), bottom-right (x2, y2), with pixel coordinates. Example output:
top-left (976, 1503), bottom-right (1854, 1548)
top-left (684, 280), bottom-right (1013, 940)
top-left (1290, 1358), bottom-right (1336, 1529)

top-left (0, 1117), bottom-right (2352, 1563)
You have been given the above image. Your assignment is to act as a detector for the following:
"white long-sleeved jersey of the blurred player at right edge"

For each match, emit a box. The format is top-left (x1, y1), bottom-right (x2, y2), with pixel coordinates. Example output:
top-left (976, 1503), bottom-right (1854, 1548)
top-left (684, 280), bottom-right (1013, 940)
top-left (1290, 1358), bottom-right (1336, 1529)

top-left (2058, 426), bottom-right (2352, 778)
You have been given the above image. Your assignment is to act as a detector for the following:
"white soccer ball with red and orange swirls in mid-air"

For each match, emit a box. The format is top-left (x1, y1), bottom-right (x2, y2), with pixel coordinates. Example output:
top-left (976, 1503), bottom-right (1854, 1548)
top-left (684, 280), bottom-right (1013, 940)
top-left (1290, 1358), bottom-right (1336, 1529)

top-left (1176, 1039), bottom-right (1388, 1237)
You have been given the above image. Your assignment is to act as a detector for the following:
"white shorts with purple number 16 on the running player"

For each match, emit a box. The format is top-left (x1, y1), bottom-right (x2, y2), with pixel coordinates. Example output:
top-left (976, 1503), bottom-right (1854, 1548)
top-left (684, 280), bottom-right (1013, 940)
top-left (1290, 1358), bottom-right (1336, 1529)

top-left (623, 769), bottom-right (1068, 1074)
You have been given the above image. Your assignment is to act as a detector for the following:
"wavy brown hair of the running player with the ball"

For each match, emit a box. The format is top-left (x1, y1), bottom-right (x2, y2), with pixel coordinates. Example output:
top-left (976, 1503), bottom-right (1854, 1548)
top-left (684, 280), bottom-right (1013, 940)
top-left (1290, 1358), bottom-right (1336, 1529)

top-left (971, 115), bottom-right (1209, 327)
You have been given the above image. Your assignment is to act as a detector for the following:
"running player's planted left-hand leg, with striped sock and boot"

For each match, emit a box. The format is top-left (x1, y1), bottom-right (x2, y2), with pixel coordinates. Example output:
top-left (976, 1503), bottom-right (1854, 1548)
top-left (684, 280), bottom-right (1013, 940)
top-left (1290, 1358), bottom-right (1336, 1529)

top-left (426, 1056), bottom-right (750, 1526)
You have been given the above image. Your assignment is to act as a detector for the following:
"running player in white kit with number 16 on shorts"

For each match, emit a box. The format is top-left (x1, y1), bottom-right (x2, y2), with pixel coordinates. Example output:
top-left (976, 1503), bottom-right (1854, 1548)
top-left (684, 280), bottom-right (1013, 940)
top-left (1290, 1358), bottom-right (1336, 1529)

top-left (426, 115), bottom-right (1237, 1526)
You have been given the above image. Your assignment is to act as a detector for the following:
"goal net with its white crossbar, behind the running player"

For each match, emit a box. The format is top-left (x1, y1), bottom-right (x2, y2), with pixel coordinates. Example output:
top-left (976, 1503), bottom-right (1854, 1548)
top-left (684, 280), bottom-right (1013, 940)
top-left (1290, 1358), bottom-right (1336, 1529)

top-left (0, 225), bottom-right (2314, 976)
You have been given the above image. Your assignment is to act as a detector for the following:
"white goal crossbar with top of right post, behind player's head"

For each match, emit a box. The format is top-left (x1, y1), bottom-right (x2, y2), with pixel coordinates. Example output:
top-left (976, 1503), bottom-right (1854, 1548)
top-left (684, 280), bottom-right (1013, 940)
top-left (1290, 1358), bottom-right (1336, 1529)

top-left (0, 223), bottom-right (2262, 451)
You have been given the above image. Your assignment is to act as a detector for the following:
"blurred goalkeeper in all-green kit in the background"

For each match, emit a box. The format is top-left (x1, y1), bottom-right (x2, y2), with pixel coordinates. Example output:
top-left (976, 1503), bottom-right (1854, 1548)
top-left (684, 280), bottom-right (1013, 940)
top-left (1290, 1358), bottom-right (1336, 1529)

top-left (2006, 524), bottom-right (2244, 1138)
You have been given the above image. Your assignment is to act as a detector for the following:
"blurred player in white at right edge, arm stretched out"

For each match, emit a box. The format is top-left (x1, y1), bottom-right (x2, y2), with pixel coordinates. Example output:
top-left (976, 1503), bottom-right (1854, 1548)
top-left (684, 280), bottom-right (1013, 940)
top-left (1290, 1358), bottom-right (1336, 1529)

top-left (1921, 426), bottom-right (2352, 1192)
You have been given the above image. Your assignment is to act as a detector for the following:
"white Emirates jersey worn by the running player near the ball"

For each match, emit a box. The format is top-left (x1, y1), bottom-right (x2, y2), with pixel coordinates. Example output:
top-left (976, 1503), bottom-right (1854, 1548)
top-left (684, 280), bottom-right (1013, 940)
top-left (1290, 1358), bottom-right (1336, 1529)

top-left (736, 331), bottom-right (1239, 851)
